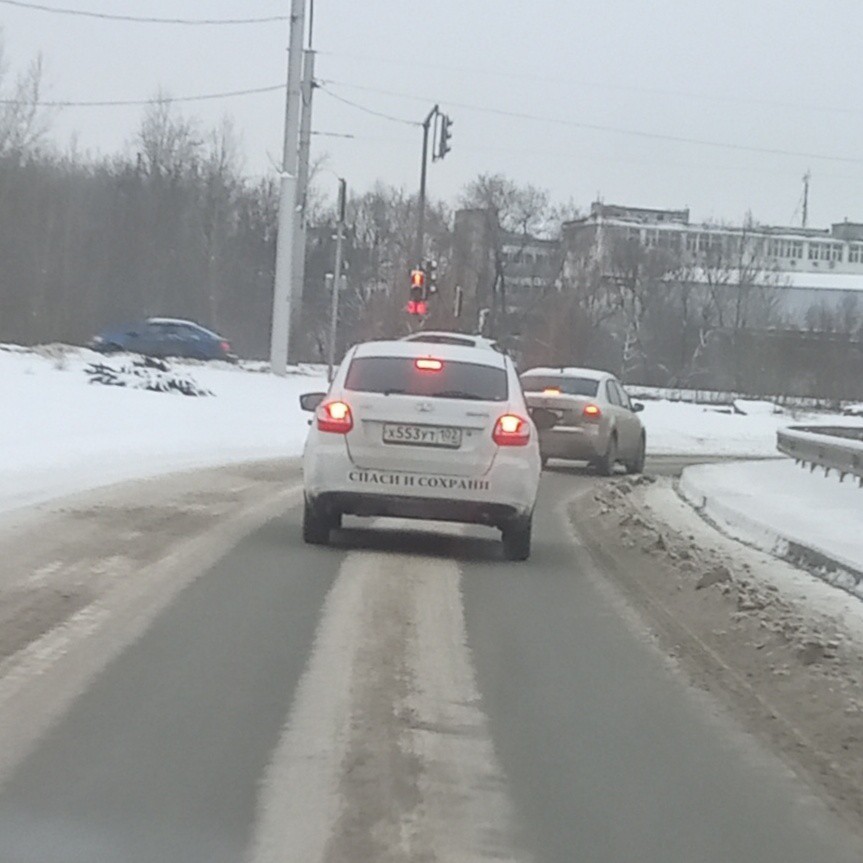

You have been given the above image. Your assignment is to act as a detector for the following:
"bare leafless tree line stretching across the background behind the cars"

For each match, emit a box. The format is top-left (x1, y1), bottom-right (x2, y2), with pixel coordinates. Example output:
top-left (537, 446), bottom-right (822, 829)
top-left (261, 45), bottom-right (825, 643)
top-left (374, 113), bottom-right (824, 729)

top-left (0, 53), bottom-right (860, 398)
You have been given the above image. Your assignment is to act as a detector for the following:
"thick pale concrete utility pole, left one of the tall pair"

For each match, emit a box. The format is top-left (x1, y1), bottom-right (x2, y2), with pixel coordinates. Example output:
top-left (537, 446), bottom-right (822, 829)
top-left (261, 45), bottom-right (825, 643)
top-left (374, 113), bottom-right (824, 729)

top-left (270, 0), bottom-right (306, 376)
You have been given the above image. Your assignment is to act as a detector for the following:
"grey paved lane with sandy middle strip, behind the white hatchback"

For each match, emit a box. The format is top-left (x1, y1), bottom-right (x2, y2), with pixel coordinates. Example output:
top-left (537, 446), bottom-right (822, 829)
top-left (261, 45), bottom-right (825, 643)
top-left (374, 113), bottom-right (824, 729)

top-left (0, 460), bottom-right (861, 863)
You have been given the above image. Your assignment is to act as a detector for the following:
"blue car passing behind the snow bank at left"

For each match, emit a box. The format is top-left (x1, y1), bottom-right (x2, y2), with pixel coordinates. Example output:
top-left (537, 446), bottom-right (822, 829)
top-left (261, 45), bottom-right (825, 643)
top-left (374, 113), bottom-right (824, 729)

top-left (87, 318), bottom-right (237, 363)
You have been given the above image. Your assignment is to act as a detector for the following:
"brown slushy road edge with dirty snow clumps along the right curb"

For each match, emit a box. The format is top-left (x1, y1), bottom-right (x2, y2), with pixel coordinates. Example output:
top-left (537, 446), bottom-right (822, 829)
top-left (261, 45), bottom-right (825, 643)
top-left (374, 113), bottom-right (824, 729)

top-left (570, 477), bottom-right (863, 823)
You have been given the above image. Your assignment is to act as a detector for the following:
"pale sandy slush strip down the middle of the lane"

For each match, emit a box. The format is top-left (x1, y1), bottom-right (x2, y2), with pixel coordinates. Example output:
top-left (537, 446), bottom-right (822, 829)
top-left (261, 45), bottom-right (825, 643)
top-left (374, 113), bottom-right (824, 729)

top-left (247, 528), bottom-right (528, 863)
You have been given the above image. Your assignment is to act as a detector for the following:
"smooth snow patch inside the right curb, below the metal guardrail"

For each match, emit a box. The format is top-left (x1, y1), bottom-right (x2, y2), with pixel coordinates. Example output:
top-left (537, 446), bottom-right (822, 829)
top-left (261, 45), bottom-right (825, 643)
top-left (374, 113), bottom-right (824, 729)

top-left (680, 459), bottom-right (863, 597)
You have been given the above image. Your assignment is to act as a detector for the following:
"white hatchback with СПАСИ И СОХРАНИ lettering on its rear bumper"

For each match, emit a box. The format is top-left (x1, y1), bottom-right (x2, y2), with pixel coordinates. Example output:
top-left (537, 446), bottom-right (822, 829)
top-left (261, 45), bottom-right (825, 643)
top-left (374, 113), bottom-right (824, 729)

top-left (300, 340), bottom-right (556, 560)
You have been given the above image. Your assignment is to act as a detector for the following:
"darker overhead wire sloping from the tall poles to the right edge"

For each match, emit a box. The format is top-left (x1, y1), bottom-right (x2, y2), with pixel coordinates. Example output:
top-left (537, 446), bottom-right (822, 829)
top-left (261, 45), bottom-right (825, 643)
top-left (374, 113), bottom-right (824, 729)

top-left (322, 81), bottom-right (863, 164)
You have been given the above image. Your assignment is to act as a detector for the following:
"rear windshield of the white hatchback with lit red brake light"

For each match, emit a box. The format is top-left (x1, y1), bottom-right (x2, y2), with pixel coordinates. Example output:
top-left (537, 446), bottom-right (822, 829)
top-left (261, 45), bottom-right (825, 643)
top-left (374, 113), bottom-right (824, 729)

top-left (345, 357), bottom-right (508, 402)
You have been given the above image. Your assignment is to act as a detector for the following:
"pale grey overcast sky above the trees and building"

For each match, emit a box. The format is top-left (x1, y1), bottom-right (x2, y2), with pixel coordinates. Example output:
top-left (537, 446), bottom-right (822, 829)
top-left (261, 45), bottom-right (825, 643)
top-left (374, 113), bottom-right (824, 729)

top-left (0, 0), bottom-right (863, 226)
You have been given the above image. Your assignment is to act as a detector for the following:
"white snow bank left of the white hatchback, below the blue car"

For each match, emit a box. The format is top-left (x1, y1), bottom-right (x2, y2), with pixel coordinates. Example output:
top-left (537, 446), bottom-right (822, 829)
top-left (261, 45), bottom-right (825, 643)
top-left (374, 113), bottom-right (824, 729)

top-left (0, 346), bottom-right (326, 510)
